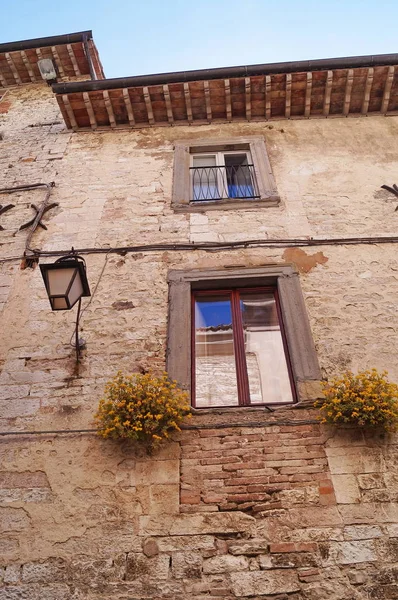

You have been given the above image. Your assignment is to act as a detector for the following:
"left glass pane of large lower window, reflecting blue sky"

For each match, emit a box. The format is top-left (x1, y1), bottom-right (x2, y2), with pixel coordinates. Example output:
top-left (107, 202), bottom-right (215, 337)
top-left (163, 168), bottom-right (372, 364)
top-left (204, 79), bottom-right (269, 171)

top-left (195, 295), bottom-right (239, 407)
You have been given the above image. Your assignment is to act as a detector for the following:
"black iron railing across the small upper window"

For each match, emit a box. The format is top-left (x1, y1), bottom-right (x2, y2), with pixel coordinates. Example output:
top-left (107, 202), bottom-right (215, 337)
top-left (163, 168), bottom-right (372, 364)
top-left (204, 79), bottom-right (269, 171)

top-left (190, 165), bottom-right (260, 202)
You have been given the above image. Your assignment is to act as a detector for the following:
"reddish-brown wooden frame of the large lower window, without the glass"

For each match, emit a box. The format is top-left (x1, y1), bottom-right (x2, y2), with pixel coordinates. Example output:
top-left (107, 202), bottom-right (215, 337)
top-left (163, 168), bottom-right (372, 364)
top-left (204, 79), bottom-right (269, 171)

top-left (191, 286), bottom-right (297, 408)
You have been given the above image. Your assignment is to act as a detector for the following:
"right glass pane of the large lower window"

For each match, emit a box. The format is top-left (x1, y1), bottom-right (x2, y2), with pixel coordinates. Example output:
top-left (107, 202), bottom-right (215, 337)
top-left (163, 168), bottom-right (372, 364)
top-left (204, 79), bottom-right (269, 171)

top-left (240, 292), bottom-right (293, 404)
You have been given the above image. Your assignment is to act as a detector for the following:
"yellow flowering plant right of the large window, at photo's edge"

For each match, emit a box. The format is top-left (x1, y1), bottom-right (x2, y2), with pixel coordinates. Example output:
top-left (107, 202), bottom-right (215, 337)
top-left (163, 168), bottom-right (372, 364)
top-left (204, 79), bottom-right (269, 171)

top-left (315, 369), bottom-right (398, 431)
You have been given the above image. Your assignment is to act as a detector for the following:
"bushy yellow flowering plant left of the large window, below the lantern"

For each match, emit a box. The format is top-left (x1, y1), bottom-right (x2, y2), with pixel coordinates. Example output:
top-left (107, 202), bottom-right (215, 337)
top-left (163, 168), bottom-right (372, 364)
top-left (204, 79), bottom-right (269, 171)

top-left (95, 371), bottom-right (191, 450)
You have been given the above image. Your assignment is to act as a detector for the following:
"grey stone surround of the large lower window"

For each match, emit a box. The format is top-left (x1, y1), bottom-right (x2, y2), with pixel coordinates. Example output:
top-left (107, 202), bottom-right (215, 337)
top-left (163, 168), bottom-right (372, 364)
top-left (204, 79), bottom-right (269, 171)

top-left (166, 264), bottom-right (322, 411)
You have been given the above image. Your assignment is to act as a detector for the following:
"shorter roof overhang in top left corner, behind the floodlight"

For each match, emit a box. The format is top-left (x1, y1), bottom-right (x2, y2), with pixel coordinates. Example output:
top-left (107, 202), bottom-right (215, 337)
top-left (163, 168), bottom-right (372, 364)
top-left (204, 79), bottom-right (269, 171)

top-left (0, 31), bottom-right (105, 88)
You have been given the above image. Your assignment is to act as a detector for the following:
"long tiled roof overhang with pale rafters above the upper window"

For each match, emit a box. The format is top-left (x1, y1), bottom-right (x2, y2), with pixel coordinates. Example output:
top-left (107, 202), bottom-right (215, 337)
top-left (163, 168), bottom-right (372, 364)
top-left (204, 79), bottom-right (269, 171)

top-left (53, 54), bottom-right (398, 130)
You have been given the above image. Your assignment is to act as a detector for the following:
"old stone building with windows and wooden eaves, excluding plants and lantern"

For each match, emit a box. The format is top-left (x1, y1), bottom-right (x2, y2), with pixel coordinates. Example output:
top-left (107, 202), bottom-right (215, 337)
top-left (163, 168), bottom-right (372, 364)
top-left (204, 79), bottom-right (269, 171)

top-left (0, 32), bottom-right (398, 600)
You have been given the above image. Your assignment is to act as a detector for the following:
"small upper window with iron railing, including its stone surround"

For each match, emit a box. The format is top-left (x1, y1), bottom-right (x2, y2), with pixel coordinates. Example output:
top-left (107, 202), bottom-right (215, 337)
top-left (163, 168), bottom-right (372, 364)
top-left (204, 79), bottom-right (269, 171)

top-left (172, 137), bottom-right (279, 211)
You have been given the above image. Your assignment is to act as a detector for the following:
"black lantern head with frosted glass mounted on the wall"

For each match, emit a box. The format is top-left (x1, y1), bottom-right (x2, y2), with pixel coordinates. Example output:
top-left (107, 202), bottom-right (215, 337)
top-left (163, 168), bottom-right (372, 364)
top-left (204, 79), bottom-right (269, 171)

top-left (40, 260), bottom-right (90, 310)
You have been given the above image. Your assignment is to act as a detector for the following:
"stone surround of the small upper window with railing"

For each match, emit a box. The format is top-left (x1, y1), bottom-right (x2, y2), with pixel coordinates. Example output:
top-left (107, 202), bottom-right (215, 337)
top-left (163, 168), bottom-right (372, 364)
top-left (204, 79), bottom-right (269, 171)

top-left (171, 136), bottom-right (280, 212)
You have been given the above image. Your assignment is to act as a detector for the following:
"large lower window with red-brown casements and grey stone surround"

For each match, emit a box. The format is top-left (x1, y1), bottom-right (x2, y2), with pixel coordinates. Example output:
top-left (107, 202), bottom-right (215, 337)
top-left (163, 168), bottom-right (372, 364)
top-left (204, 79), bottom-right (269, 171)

top-left (167, 265), bottom-right (321, 408)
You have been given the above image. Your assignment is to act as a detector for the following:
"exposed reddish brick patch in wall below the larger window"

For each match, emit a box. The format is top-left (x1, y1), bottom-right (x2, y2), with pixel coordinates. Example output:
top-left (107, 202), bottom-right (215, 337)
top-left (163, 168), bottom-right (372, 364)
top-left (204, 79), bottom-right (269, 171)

top-left (180, 425), bottom-right (336, 515)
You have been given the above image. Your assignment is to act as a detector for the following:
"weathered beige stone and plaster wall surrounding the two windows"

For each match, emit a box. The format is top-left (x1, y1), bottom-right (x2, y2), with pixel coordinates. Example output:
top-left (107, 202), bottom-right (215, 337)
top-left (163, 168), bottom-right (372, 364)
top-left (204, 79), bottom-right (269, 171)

top-left (0, 86), bottom-right (398, 600)
